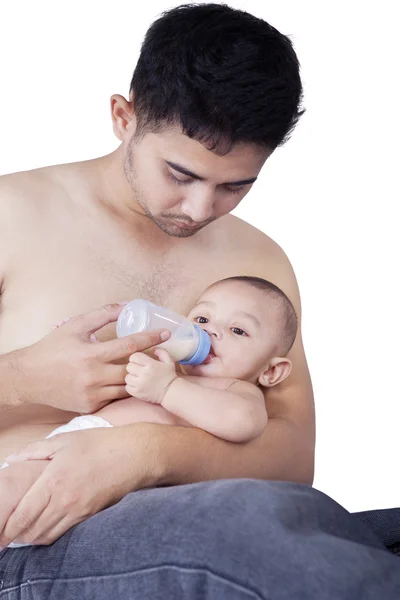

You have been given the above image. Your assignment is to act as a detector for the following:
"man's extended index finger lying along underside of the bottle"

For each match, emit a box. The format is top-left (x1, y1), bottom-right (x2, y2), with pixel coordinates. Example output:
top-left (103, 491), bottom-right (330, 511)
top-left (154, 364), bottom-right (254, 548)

top-left (101, 329), bottom-right (170, 361)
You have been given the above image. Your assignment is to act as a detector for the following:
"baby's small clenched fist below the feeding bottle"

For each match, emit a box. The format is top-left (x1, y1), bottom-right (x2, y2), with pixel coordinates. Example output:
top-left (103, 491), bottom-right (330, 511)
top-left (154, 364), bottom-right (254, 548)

top-left (125, 348), bottom-right (178, 404)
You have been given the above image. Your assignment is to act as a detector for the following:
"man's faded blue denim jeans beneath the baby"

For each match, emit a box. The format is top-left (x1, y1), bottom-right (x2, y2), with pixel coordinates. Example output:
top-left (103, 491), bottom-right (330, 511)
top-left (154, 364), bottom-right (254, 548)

top-left (0, 479), bottom-right (400, 600)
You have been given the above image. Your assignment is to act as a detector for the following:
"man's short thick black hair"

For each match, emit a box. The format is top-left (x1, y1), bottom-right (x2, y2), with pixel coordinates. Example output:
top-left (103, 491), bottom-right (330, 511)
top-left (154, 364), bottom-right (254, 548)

top-left (129, 3), bottom-right (304, 156)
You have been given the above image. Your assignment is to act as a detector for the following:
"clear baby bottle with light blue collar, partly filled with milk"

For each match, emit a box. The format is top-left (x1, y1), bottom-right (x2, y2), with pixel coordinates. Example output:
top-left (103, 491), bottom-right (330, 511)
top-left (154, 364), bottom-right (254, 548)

top-left (117, 298), bottom-right (211, 365)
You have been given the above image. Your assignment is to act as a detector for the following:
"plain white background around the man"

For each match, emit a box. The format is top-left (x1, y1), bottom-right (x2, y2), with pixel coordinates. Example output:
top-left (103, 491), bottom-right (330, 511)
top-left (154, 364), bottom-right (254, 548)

top-left (0, 0), bottom-right (400, 511)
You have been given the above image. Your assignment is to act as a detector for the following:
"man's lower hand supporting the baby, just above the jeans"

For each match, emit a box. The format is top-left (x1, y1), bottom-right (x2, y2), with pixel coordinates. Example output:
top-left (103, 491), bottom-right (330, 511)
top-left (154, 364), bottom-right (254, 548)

top-left (0, 423), bottom-right (160, 546)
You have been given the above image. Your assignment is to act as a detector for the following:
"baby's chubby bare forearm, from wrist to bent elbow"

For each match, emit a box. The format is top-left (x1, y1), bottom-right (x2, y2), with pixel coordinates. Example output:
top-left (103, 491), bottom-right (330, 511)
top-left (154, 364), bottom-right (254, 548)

top-left (161, 377), bottom-right (268, 442)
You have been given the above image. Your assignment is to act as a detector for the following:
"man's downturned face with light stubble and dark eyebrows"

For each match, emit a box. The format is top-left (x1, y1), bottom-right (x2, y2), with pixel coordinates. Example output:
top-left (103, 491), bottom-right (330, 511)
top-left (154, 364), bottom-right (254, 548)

top-left (123, 128), bottom-right (271, 237)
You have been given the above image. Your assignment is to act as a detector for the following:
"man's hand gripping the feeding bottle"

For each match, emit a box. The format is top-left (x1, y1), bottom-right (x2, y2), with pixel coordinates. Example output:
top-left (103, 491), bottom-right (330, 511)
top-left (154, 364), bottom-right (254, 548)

top-left (14, 304), bottom-right (170, 413)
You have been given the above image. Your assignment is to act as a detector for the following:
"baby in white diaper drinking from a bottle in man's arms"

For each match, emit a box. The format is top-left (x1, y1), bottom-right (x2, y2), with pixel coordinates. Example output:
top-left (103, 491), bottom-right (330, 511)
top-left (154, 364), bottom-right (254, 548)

top-left (1, 276), bottom-right (297, 547)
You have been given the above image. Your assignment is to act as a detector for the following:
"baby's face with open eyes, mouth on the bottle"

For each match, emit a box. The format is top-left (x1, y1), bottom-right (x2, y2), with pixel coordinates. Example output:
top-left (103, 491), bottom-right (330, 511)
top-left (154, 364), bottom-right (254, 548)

top-left (183, 281), bottom-right (280, 383)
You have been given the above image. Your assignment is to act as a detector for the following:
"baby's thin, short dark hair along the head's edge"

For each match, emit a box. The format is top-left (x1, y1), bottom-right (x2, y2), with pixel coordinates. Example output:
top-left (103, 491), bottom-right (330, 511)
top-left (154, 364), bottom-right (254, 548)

top-left (210, 275), bottom-right (298, 356)
